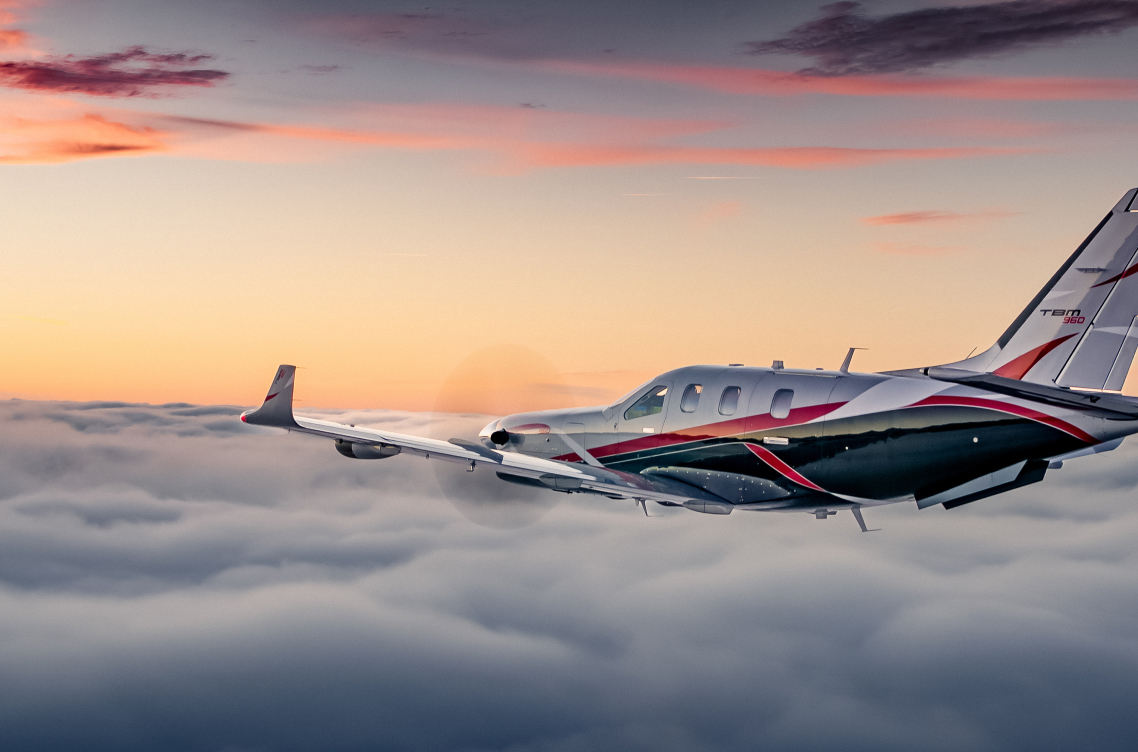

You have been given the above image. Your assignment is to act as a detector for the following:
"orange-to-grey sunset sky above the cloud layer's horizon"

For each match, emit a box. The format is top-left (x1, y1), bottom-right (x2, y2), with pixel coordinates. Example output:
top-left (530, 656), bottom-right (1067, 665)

top-left (0, 0), bottom-right (1138, 410)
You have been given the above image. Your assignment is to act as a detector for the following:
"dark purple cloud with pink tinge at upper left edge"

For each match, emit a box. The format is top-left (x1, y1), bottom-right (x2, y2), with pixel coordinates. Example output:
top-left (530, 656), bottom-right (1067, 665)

top-left (0, 47), bottom-right (229, 97)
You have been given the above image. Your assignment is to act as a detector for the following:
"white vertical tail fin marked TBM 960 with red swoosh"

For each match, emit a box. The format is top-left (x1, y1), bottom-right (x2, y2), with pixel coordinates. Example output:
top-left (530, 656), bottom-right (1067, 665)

top-left (949, 189), bottom-right (1138, 390)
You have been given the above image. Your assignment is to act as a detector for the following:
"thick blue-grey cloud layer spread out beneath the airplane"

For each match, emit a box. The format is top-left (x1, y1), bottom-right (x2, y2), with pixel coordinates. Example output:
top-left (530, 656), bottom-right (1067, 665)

top-left (0, 400), bottom-right (1138, 752)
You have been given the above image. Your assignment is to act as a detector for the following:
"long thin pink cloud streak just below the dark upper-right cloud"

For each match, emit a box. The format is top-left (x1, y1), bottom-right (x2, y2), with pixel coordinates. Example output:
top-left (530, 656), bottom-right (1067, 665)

top-left (548, 60), bottom-right (1138, 101)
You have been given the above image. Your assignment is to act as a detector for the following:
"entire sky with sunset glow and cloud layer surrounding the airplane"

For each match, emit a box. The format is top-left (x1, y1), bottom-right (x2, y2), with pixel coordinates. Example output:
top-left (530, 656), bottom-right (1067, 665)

top-left (0, 0), bottom-right (1138, 752)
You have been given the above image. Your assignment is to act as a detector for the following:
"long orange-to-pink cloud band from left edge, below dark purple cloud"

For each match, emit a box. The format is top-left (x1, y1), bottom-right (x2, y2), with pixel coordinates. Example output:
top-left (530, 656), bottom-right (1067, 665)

top-left (0, 105), bottom-right (1029, 168)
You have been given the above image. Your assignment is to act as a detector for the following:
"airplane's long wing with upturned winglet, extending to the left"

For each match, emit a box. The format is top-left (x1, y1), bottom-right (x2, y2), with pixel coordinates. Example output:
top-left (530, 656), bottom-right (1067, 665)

top-left (241, 365), bottom-right (734, 514)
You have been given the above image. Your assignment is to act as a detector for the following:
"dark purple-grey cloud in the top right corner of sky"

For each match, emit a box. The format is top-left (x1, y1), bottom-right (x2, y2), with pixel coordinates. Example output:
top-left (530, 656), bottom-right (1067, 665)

top-left (749, 0), bottom-right (1138, 76)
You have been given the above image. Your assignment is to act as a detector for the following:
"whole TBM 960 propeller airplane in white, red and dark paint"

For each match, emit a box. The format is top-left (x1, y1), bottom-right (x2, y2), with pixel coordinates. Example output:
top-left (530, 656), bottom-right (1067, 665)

top-left (241, 189), bottom-right (1138, 531)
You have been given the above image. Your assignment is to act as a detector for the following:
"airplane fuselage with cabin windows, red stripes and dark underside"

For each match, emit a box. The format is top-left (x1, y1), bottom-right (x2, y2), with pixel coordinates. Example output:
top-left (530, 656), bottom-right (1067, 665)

top-left (480, 365), bottom-right (1138, 510)
